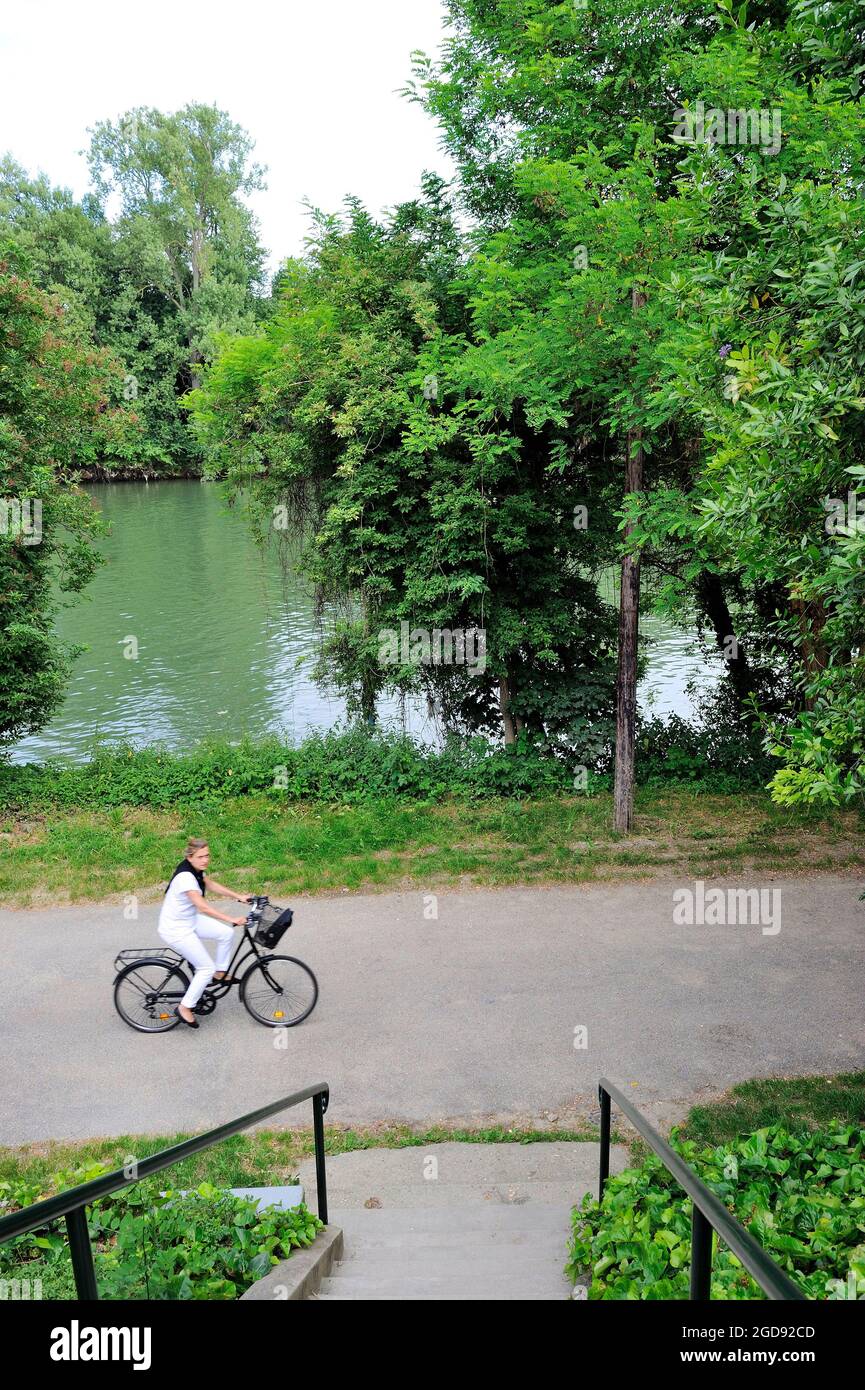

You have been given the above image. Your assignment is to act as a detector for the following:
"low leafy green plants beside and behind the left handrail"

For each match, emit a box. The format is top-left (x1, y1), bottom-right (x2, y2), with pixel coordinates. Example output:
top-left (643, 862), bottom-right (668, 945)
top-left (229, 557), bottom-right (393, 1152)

top-left (0, 1163), bottom-right (323, 1300)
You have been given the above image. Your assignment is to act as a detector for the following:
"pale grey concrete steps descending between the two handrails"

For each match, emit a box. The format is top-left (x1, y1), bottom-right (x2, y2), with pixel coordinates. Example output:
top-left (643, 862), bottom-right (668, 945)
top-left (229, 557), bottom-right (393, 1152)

top-left (300, 1141), bottom-right (624, 1301)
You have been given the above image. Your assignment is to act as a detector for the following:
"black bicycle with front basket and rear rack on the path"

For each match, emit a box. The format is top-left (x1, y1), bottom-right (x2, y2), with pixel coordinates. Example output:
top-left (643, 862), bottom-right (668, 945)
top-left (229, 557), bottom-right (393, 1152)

top-left (114, 897), bottom-right (318, 1033)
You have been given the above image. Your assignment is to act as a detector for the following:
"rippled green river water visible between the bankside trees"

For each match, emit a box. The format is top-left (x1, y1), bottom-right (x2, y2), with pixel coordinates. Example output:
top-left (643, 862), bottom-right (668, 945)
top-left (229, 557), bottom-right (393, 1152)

top-left (14, 482), bottom-right (723, 762)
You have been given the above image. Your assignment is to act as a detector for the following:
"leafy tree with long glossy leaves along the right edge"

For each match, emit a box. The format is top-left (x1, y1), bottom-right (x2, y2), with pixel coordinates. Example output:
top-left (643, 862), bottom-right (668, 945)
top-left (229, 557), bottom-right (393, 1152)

top-left (631, 6), bottom-right (865, 803)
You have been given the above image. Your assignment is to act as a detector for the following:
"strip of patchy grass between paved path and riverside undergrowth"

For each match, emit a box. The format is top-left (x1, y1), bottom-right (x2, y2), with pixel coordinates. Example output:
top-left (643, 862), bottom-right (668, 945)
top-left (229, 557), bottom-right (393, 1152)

top-left (0, 787), bottom-right (865, 908)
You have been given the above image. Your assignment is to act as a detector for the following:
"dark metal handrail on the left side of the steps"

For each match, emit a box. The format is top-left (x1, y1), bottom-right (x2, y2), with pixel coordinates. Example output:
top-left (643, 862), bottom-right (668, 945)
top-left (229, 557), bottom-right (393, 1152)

top-left (0, 1081), bottom-right (331, 1301)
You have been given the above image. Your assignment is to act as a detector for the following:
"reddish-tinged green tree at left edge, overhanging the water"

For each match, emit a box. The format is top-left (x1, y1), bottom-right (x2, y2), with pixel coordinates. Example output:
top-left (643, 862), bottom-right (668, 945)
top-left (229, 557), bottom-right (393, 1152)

top-left (0, 246), bottom-right (135, 745)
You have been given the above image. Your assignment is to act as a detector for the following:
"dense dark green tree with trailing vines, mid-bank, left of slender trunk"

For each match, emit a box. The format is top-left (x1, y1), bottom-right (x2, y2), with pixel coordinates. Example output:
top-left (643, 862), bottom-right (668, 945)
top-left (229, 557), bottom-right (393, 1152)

top-left (193, 187), bottom-right (613, 760)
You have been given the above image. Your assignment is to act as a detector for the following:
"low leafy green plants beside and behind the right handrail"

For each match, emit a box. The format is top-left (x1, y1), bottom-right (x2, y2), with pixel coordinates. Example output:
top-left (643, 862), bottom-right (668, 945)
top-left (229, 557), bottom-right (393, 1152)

top-left (567, 1122), bottom-right (865, 1300)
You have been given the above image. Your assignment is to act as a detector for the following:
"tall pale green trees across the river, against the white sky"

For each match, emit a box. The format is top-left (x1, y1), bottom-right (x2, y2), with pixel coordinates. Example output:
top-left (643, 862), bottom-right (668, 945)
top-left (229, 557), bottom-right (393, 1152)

top-left (0, 104), bottom-right (266, 475)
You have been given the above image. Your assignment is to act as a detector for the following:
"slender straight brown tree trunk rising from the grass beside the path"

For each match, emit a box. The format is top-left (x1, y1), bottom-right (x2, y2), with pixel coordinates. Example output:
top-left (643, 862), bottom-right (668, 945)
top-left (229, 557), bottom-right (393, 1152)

top-left (613, 289), bottom-right (645, 831)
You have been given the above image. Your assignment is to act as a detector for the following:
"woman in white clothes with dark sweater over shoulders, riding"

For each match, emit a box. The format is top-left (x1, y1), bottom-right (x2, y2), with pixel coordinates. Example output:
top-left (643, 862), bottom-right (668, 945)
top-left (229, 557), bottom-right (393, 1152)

top-left (159, 840), bottom-right (252, 1029)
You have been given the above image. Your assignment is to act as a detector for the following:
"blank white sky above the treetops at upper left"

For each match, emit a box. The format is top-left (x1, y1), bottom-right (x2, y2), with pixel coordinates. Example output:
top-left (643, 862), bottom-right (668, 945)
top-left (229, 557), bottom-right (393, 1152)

top-left (0, 0), bottom-right (452, 271)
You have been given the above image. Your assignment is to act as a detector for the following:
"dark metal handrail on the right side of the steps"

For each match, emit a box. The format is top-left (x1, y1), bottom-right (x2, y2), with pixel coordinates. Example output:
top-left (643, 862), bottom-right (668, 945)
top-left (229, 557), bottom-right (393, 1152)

top-left (598, 1077), bottom-right (807, 1301)
